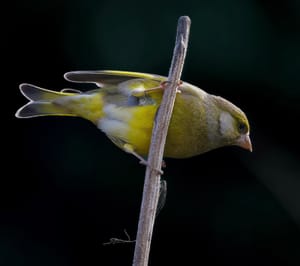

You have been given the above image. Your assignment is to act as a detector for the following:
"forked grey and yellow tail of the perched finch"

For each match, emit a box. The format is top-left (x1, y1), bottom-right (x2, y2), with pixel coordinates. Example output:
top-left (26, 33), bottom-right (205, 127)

top-left (16, 83), bottom-right (76, 118)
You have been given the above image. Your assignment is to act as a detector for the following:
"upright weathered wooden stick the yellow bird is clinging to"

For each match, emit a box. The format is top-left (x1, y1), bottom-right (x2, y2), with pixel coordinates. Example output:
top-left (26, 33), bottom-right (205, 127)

top-left (133, 16), bottom-right (191, 266)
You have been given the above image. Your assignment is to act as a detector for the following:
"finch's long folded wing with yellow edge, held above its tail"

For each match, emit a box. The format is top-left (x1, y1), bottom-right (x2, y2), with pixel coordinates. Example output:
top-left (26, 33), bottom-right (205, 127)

top-left (64, 70), bottom-right (167, 87)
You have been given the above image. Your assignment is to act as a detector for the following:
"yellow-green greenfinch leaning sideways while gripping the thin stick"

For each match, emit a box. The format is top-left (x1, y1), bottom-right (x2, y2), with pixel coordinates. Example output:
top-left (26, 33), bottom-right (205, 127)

top-left (16, 70), bottom-right (252, 158)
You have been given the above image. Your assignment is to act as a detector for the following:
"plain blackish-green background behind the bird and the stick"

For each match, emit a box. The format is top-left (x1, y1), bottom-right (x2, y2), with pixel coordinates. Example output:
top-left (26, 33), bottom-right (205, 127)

top-left (0, 0), bottom-right (300, 266)
